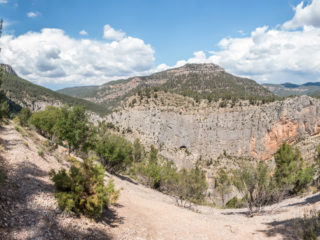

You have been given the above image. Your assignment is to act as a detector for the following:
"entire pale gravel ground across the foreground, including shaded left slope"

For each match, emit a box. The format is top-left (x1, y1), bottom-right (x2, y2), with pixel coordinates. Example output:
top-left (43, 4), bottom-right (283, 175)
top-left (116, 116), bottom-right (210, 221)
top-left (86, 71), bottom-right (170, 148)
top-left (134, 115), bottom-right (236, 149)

top-left (0, 125), bottom-right (320, 240)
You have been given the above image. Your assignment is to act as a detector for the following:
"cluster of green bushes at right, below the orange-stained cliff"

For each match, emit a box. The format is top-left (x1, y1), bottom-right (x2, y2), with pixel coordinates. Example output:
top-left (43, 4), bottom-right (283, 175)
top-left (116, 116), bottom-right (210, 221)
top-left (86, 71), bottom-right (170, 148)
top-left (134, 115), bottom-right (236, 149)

top-left (216, 143), bottom-right (320, 216)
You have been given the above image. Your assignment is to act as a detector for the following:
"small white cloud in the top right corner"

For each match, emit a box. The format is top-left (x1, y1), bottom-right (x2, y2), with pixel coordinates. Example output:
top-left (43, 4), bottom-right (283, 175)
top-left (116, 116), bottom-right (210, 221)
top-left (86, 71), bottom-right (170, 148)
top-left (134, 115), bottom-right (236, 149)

top-left (283, 0), bottom-right (320, 29)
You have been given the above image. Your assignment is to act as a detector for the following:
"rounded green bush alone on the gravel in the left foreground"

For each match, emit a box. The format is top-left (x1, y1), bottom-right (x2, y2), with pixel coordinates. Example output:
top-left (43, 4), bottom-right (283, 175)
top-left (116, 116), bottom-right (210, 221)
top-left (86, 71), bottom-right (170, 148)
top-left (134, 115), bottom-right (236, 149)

top-left (50, 159), bottom-right (119, 218)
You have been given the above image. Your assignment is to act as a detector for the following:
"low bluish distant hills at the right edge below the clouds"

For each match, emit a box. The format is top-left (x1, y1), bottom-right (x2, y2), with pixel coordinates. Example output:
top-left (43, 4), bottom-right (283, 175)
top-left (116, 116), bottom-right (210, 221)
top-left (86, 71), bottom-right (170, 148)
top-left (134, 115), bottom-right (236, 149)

top-left (263, 82), bottom-right (320, 97)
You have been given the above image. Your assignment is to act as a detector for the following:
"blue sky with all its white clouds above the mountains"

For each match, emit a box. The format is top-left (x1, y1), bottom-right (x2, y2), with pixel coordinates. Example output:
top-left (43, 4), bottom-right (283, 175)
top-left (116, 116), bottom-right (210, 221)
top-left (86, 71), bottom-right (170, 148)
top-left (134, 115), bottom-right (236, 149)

top-left (0, 0), bottom-right (320, 90)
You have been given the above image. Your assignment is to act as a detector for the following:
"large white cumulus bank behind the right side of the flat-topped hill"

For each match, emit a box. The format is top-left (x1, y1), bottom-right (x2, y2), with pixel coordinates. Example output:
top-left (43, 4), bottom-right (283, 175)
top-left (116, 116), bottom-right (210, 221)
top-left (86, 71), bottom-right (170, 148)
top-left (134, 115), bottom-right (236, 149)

top-left (161, 0), bottom-right (320, 83)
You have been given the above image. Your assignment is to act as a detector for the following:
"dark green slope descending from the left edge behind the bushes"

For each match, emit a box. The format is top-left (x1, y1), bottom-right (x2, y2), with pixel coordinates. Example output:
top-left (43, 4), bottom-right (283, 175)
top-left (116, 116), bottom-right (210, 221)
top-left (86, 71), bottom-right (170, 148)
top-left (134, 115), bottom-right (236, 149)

top-left (0, 64), bottom-right (107, 115)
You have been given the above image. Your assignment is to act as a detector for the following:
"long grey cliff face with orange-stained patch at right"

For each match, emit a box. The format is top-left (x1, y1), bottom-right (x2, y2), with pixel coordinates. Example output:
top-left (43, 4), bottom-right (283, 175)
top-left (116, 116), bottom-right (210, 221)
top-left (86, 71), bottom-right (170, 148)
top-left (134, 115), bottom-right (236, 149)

top-left (107, 96), bottom-right (320, 166)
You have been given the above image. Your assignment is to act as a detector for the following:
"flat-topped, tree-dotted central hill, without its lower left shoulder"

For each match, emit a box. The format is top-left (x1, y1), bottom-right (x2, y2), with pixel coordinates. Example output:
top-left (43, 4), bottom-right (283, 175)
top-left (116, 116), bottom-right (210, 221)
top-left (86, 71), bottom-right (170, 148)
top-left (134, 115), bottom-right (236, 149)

top-left (150, 64), bottom-right (274, 100)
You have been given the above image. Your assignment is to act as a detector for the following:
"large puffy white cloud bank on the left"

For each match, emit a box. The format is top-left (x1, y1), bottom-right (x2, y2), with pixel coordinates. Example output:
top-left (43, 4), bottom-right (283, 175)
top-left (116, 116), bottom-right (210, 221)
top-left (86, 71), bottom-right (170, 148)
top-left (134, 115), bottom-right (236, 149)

top-left (0, 29), bottom-right (154, 86)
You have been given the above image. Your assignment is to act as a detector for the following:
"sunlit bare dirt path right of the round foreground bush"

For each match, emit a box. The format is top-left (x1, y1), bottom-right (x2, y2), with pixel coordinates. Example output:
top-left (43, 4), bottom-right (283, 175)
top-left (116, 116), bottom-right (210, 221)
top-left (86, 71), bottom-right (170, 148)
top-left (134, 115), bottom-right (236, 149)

top-left (115, 167), bottom-right (320, 240)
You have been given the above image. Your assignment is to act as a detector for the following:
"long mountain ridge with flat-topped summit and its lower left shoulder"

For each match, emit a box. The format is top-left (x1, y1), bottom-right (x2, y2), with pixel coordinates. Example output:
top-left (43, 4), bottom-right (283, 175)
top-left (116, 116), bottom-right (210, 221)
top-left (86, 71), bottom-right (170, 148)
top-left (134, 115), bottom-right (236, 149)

top-left (58, 64), bottom-right (274, 106)
